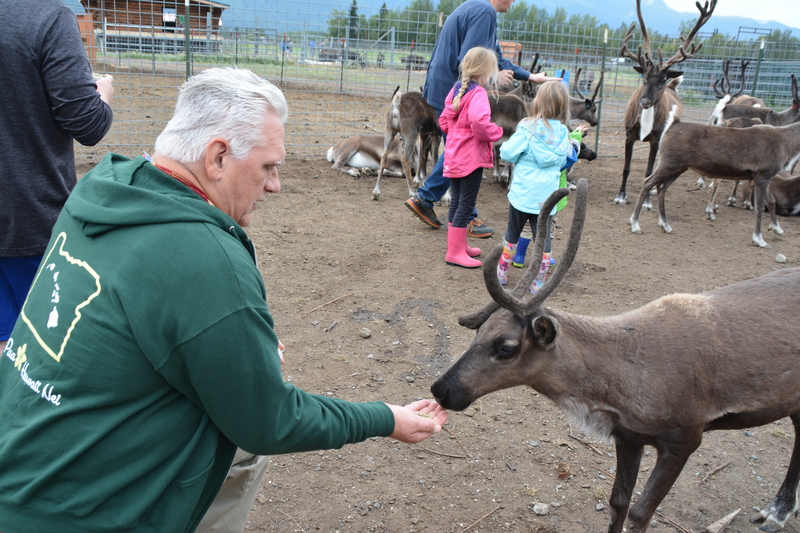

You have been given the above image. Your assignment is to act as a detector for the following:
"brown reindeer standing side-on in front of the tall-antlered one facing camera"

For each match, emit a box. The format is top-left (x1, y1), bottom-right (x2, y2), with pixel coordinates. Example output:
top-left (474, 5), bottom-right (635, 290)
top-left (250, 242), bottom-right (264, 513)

top-left (630, 109), bottom-right (800, 248)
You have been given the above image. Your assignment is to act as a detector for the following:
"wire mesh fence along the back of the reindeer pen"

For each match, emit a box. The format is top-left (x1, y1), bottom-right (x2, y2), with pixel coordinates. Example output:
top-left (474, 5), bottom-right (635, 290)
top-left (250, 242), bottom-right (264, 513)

top-left (76, 0), bottom-right (800, 165)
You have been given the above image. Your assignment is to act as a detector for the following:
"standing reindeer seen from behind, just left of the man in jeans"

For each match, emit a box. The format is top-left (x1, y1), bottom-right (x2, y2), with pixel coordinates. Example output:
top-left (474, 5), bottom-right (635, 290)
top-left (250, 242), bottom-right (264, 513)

top-left (372, 87), bottom-right (442, 200)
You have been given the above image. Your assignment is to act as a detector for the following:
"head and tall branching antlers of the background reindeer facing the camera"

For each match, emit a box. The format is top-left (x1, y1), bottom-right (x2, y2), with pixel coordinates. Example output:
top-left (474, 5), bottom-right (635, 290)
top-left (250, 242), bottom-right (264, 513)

top-left (619, 0), bottom-right (717, 109)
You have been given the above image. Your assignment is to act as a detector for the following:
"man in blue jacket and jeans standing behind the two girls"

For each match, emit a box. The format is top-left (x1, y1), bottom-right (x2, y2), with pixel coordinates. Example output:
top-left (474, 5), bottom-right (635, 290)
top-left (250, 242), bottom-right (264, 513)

top-left (406, 0), bottom-right (561, 238)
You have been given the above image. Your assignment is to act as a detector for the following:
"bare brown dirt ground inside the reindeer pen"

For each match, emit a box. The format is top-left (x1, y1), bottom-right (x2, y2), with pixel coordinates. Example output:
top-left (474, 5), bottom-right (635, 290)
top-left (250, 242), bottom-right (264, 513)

top-left (241, 152), bottom-right (800, 533)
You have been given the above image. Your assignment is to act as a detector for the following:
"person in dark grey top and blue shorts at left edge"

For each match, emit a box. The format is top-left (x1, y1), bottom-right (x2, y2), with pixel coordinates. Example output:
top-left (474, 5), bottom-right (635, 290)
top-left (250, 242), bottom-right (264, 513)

top-left (0, 0), bottom-right (114, 350)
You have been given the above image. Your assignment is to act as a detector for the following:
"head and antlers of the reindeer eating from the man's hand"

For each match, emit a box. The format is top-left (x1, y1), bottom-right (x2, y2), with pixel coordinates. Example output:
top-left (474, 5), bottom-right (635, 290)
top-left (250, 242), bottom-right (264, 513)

top-left (431, 179), bottom-right (588, 411)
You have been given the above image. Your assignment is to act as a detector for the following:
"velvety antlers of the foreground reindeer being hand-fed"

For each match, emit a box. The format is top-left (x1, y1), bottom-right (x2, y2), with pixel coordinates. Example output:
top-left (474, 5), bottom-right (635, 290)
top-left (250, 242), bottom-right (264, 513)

top-left (458, 179), bottom-right (589, 329)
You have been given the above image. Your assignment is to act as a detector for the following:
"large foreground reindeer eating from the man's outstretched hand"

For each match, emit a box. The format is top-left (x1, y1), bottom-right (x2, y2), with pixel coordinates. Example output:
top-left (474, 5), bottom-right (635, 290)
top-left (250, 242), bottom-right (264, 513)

top-left (431, 180), bottom-right (800, 533)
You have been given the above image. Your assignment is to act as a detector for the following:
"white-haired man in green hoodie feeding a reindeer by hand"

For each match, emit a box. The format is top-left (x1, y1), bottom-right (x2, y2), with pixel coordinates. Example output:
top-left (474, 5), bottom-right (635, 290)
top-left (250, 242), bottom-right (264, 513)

top-left (0, 68), bottom-right (447, 533)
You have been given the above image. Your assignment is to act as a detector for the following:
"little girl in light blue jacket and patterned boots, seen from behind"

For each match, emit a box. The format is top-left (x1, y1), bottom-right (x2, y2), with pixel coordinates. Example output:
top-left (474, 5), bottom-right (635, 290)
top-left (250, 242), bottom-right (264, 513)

top-left (497, 81), bottom-right (576, 293)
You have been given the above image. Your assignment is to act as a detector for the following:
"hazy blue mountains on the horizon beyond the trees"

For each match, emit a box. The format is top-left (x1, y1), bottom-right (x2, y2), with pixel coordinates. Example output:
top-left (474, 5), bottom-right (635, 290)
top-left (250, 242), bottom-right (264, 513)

top-left (64, 0), bottom-right (800, 40)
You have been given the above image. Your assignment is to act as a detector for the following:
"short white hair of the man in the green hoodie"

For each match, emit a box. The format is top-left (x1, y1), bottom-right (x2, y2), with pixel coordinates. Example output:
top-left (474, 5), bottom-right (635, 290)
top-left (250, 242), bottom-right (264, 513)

top-left (155, 68), bottom-right (289, 164)
